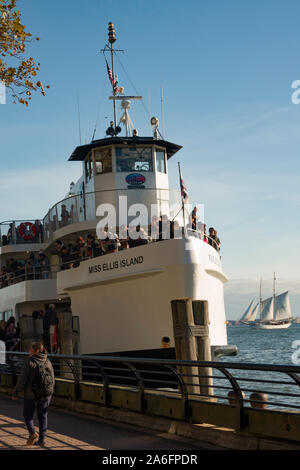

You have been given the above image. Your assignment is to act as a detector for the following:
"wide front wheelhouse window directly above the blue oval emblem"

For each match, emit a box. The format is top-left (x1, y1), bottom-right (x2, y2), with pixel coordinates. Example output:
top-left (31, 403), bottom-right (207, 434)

top-left (116, 147), bottom-right (153, 172)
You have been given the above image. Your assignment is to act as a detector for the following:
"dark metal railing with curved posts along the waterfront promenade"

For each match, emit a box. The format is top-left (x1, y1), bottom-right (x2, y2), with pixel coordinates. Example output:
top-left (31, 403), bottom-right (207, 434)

top-left (0, 352), bottom-right (300, 435)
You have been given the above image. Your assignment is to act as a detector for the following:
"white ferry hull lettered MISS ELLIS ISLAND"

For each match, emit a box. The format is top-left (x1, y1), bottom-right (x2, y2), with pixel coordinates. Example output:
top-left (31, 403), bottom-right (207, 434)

top-left (58, 238), bottom-right (231, 357)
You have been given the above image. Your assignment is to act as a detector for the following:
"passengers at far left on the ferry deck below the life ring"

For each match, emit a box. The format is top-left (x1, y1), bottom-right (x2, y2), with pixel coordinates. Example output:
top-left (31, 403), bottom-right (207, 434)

top-left (0, 251), bottom-right (50, 288)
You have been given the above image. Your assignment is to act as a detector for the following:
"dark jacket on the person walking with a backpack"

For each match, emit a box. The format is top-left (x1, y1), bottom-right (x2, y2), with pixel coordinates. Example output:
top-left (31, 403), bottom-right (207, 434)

top-left (13, 352), bottom-right (54, 400)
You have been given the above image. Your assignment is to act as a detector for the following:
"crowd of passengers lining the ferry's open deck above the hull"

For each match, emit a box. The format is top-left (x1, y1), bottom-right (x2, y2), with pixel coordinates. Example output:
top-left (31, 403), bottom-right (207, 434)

top-left (0, 214), bottom-right (221, 288)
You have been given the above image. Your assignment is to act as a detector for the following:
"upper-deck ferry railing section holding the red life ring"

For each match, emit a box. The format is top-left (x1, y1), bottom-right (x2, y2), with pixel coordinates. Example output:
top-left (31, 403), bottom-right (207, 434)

top-left (0, 219), bottom-right (44, 246)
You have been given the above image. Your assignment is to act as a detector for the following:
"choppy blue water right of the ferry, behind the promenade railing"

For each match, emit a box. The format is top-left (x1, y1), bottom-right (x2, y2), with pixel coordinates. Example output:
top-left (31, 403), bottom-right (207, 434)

top-left (214, 324), bottom-right (300, 412)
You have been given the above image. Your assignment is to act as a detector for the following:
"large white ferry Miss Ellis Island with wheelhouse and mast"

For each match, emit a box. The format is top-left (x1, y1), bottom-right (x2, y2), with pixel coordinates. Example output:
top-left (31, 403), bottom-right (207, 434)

top-left (0, 24), bottom-right (236, 358)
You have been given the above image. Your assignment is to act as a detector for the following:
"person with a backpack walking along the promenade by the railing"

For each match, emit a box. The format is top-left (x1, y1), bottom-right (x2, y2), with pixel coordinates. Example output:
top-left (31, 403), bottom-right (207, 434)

top-left (12, 342), bottom-right (55, 447)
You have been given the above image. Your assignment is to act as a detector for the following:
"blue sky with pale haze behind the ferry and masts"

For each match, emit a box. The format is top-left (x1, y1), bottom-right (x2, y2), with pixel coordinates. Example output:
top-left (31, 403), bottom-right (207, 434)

top-left (0, 0), bottom-right (300, 318)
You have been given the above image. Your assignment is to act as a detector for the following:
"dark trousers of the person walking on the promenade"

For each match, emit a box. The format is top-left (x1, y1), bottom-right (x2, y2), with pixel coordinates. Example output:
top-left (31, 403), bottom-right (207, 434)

top-left (23, 397), bottom-right (51, 441)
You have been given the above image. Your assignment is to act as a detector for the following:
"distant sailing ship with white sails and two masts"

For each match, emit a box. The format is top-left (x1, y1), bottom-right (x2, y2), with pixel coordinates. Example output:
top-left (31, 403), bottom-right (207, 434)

top-left (240, 273), bottom-right (292, 330)
